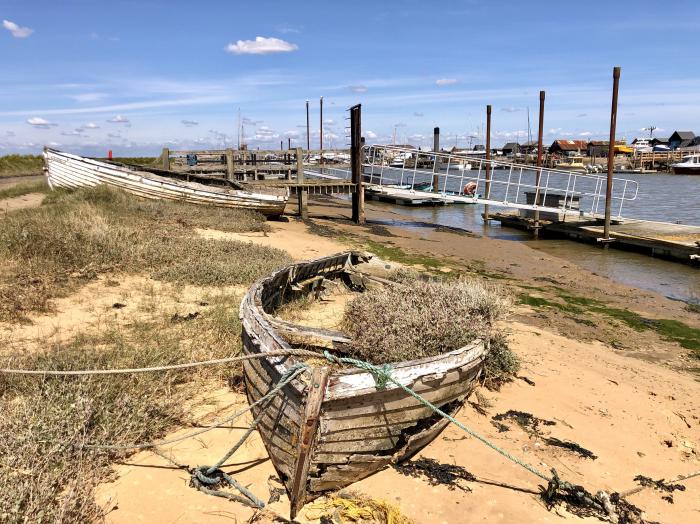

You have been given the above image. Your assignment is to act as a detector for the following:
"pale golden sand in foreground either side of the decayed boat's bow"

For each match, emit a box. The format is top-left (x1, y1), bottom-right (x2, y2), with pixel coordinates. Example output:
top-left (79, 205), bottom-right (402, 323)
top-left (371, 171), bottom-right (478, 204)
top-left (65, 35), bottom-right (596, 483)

top-left (98, 323), bottom-right (700, 523)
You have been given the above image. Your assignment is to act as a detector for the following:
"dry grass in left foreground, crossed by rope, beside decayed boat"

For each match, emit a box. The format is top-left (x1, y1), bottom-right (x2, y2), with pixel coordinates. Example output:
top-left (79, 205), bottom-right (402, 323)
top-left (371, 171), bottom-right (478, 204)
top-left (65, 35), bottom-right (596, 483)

top-left (0, 288), bottom-right (240, 522)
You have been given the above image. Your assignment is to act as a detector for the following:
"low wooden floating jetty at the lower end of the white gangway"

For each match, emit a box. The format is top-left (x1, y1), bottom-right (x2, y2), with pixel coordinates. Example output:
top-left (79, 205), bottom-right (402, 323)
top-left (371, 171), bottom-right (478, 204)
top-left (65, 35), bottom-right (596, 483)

top-left (489, 212), bottom-right (700, 263)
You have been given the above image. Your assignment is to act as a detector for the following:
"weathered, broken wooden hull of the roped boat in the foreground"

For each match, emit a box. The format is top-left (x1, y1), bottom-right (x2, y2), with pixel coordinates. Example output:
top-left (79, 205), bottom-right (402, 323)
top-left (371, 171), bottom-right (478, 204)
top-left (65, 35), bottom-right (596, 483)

top-left (240, 252), bottom-right (486, 518)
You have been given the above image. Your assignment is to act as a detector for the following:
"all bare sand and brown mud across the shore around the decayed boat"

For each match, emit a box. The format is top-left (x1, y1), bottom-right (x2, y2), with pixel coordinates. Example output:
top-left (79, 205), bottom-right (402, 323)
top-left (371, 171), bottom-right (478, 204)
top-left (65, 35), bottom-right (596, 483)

top-left (3, 193), bottom-right (700, 523)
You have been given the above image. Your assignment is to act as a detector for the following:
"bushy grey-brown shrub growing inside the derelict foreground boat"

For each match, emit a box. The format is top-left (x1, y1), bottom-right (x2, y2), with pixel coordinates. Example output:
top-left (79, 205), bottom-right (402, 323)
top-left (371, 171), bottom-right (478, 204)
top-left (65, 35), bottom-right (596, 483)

top-left (342, 279), bottom-right (511, 364)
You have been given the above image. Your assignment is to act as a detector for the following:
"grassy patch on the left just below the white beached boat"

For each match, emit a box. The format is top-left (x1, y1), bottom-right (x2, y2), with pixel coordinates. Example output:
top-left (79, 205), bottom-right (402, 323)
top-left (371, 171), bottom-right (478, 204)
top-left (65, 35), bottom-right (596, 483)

top-left (0, 185), bottom-right (290, 320)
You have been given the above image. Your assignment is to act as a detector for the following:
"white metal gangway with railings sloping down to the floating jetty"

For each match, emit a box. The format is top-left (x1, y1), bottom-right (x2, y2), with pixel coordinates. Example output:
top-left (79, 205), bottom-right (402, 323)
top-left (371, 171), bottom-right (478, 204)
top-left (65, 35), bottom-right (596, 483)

top-left (358, 146), bottom-right (638, 217)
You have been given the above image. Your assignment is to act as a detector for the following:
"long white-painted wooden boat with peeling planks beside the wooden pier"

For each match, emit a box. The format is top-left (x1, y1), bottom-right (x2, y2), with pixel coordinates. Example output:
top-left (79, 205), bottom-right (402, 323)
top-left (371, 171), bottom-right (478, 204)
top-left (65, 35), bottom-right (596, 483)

top-left (44, 148), bottom-right (289, 216)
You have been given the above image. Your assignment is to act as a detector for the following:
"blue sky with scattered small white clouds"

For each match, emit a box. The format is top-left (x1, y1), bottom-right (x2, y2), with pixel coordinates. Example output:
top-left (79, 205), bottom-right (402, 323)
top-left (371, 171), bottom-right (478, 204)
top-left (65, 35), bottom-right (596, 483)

top-left (0, 0), bottom-right (700, 156)
